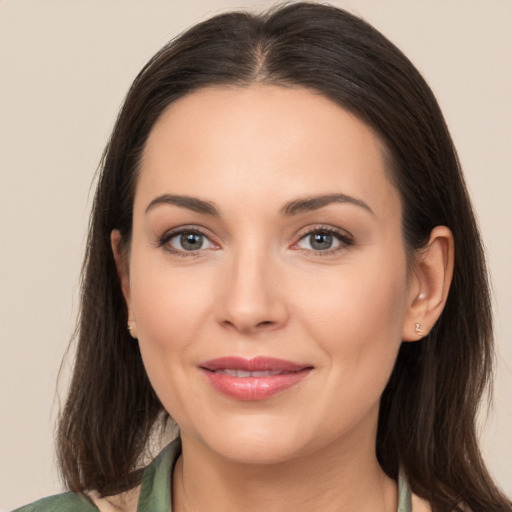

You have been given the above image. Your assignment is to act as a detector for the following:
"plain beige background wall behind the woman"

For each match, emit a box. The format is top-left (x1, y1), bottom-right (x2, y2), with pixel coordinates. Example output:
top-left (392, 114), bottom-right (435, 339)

top-left (0, 0), bottom-right (512, 509)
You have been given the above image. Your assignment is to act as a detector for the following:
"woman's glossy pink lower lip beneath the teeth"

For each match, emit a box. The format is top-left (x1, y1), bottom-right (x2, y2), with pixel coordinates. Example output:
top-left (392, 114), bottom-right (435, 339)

top-left (201, 368), bottom-right (311, 400)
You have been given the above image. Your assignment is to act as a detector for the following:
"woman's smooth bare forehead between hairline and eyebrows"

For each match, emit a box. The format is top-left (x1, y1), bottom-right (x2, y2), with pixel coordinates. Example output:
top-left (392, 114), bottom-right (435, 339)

top-left (136, 85), bottom-right (396, 218)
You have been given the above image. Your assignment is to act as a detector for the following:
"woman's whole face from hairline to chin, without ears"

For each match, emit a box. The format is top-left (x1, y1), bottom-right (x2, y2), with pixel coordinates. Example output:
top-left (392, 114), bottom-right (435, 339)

top-left (119, 85), bottom-right (415, 463)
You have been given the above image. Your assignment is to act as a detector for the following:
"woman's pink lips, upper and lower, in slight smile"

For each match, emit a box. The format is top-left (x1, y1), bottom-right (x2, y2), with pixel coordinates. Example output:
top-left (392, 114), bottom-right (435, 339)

top-left (198, 356), bottom-right (313, 401)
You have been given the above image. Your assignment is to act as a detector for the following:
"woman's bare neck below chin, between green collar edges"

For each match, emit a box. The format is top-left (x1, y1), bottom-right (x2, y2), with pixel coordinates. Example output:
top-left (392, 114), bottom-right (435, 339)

top-left (173, 428), bottom-right (397, 512)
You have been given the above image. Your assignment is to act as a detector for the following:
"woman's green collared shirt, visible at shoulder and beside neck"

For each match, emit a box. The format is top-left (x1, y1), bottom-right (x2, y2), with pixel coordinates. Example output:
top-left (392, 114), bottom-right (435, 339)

top-left (13, 440), bottom-right (412, 512)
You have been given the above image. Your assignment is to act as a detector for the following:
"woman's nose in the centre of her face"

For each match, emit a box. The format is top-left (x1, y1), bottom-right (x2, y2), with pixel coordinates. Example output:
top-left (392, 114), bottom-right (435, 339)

top-left (216, 249), bottom-right (289, 335)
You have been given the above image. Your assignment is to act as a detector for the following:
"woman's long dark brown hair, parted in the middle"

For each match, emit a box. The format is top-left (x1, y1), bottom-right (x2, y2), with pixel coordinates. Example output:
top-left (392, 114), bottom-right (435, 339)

top-left (58, 3), bottom-right (511, 512)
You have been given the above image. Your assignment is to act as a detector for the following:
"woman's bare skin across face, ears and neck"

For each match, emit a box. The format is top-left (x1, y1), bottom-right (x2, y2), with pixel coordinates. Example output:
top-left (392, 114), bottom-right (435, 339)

top-left (112, 85), bottom-right (453, 512)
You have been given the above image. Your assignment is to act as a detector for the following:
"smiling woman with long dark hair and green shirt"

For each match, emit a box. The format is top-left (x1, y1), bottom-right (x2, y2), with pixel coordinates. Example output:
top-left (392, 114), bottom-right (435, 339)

top-left (14, 4), bottom-right (511, 512)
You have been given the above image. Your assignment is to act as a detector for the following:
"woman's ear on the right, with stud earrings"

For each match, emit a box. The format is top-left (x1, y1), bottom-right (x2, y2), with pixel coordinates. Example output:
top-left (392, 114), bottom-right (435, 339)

top-left (402, 226), bottom-right (454, 341)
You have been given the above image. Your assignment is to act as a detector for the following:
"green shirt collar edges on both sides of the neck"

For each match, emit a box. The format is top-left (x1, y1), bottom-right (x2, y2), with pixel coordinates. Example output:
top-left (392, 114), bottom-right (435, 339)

top-left (137, 438), bottom-right (412, 512)
